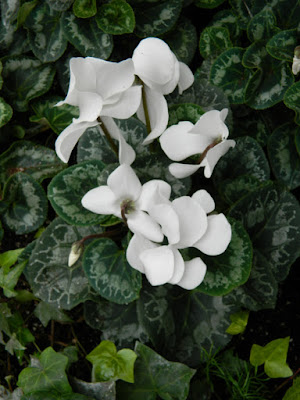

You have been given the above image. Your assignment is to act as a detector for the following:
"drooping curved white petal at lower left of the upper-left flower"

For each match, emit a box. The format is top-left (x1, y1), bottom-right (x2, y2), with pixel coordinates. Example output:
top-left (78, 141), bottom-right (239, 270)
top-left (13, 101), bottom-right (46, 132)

top-left (55, 121), bottom-right (98, 163)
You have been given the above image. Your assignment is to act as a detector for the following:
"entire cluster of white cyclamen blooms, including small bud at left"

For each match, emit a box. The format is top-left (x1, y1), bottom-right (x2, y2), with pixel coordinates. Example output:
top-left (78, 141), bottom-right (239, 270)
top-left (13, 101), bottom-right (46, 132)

top-left (56, 38), bottom-right (235, 290)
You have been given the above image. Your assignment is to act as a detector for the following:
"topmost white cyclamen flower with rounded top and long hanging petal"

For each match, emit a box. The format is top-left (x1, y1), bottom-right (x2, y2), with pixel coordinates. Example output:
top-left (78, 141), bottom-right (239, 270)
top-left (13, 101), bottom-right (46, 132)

top-left (132, 37), bottom-right (194, 144)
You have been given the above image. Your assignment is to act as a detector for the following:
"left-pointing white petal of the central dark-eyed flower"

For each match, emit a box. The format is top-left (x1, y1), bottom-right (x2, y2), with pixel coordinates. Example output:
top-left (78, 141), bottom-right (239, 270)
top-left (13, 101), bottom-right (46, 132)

top-left (81, 186), bottom-right (120, 215)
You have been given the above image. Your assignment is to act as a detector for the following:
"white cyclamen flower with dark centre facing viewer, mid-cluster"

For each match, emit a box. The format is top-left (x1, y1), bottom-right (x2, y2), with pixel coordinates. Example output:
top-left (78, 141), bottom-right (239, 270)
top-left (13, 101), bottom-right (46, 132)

top-left (81, 164), bottom-right (171, 242)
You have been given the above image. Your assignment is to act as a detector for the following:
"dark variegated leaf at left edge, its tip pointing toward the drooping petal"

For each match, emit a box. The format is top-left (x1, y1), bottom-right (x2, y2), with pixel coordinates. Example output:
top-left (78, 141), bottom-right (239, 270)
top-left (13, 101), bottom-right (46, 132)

top-left (0, 140), bottom-right (66, 185)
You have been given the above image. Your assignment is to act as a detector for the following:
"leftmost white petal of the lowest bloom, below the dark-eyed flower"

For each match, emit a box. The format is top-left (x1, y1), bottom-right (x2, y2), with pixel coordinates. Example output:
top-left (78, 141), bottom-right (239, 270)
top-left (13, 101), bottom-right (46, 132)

top-left (126, 234), bottom-right (159, 273)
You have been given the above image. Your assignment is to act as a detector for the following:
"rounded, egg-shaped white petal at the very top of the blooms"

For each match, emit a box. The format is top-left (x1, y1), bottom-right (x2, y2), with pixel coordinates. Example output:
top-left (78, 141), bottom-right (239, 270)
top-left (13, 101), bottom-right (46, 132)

top-left (132, 37), bottom-right (174, 87)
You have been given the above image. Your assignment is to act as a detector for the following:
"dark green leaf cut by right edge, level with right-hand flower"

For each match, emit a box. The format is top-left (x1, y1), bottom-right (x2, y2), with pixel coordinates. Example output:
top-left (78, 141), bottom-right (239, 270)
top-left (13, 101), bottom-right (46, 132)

top-left (268, 122), bottom-right (300, 189)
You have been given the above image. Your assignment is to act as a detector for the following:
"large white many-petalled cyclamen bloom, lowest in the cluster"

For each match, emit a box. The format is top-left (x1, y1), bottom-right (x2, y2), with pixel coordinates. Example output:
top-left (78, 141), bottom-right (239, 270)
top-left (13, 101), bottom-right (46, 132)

top-left (126, 190), bottom-right (231, 290)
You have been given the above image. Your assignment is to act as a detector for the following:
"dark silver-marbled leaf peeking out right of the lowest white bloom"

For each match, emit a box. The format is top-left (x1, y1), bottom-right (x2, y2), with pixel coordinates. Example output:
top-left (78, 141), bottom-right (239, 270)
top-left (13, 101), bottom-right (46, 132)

top-left (198, 219), bottom-right (252, 296)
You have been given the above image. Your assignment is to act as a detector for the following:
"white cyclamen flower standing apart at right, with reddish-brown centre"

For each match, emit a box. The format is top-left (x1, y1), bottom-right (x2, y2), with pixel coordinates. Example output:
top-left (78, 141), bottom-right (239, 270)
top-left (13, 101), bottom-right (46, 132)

top-left (160, 108), bottom-right (235, 178)
